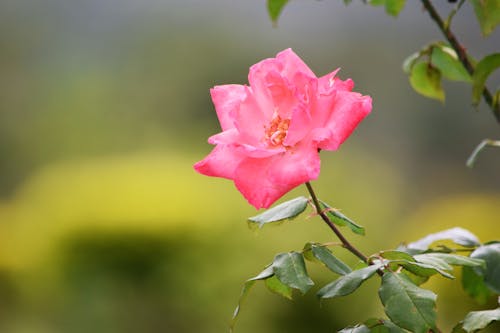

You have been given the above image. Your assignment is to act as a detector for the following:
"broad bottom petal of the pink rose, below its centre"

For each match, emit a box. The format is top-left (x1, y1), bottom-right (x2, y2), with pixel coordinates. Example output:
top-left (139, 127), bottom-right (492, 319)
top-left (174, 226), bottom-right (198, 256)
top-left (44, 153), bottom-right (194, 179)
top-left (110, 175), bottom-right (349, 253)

top-left (234, 145), bottom-right (320, 209)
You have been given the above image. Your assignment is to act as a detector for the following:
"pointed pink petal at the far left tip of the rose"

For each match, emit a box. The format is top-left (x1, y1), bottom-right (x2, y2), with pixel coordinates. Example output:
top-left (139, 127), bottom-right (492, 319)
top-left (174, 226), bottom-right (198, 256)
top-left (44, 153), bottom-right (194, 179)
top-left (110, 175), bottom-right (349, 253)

top-left (194, 145), bottom-right (245, 179)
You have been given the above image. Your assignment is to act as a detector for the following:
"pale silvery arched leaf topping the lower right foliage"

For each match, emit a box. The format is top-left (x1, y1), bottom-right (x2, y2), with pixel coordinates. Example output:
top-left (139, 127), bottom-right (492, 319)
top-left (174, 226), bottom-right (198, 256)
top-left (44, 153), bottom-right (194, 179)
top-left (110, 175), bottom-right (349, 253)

top-left (407, 227), bottom-right (480, 251)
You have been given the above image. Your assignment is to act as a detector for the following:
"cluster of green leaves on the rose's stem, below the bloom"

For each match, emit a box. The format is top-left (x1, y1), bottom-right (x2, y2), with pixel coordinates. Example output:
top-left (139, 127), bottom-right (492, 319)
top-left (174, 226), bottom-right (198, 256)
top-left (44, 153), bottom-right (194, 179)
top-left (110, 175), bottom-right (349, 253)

top-left (231, 197), bottom-right (500, 333)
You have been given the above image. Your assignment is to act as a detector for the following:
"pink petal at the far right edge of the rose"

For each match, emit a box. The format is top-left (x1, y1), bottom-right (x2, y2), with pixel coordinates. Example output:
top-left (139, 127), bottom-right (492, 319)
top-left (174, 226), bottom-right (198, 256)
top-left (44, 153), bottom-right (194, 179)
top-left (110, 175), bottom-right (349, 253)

top-left (319, 91), bottom-right (372, 150)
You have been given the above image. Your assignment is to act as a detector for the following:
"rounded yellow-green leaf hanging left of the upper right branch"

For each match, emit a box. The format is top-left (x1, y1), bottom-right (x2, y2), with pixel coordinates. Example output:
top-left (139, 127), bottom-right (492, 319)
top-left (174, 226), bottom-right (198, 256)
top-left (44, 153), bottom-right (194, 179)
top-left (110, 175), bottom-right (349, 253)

top-left (410, 62), bottom-right (444, 102)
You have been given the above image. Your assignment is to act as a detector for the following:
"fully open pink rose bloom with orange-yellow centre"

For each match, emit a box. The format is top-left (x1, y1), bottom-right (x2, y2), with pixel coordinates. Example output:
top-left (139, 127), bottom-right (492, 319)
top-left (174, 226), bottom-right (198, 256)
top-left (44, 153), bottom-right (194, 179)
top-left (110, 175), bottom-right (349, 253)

top-left (194, 49), bottom-right (372, 209)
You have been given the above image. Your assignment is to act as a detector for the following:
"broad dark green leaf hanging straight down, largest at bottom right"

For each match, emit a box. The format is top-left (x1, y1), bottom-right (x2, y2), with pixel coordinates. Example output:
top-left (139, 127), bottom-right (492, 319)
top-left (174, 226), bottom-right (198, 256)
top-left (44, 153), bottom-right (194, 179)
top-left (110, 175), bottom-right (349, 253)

top-left (379, 272), bottom-right (437, 333)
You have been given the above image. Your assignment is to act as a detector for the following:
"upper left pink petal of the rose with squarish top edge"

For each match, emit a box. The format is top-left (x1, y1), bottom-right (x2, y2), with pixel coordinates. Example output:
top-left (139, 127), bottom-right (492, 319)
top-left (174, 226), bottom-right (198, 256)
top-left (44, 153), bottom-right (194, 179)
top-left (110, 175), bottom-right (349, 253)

top-left (210, 84), bottom-right (247, 131)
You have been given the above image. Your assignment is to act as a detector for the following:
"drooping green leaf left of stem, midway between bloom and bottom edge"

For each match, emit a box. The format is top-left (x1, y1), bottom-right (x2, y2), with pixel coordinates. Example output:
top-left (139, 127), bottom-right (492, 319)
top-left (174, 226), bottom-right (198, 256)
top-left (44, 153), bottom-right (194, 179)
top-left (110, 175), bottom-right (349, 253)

top-left (272, 251), bottom-right (314, 294)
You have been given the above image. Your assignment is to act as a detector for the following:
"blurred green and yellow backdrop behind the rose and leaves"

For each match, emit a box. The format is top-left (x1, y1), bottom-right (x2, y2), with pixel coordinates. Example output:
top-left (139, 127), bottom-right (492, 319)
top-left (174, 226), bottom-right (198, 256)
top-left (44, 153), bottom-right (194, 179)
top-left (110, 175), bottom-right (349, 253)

top-left (0, 0), bottom-right (500, 333)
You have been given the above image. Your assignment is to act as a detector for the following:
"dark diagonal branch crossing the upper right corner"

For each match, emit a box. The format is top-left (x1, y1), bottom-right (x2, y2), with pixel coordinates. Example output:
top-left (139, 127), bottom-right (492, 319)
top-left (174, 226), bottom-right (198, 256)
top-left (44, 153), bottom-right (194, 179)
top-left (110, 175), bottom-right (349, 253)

top-left (422, 0), bottom-right (500, 123)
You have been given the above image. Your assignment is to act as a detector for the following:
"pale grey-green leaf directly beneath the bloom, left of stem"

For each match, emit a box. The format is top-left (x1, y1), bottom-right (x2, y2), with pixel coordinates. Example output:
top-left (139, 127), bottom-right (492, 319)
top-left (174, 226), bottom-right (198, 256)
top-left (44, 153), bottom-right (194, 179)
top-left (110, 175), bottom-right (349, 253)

top-left (248, 197), bottom-right (309, 228)
